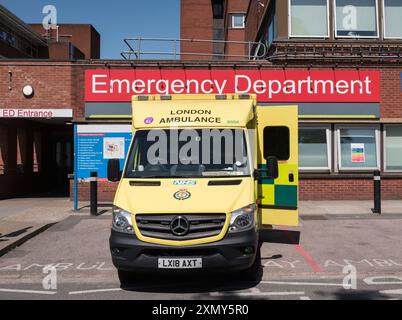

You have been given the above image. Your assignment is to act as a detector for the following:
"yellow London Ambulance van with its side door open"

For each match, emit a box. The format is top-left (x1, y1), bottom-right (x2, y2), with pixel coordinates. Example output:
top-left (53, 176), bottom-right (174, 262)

top-left (108, 94), bottom-right (298, 282)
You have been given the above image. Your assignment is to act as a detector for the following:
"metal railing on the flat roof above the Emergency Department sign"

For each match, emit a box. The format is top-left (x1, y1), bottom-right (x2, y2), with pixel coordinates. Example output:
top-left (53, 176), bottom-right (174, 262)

top-left (120, 37), bottom-right (268, 60)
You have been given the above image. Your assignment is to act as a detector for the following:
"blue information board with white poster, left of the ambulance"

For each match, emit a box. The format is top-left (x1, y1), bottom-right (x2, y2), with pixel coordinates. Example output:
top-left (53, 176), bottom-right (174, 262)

top-left (75, 125), bottom-right (132, 180)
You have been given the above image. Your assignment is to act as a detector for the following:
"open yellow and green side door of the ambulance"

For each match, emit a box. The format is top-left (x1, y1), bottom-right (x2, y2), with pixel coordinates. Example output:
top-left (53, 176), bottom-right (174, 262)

top-left (256, 106), bottom-right (299, 226)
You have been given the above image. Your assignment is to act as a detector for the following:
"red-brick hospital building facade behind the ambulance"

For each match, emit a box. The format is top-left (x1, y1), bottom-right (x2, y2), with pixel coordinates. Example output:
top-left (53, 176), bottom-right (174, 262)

top-left (0, 0), bottom-right (402, 201)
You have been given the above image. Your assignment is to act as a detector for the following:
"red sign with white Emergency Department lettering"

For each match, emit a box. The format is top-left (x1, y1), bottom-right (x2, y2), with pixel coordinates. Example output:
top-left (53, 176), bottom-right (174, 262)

top-left (85, 69), bottom-right (380, 103)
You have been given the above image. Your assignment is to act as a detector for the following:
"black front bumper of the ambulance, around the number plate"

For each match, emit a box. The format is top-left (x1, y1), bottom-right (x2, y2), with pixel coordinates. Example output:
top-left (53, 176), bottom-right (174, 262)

top-left (109, 230), bottom-right (258, 272)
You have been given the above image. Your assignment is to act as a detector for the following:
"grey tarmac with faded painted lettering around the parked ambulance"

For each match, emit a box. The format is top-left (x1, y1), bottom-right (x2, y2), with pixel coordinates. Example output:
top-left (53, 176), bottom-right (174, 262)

top-left (0, 215), bottom-right (402, 300)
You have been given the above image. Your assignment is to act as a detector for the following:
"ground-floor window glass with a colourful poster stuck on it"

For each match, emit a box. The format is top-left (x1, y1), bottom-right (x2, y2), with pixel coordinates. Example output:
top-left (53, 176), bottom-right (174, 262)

top-left (337, 127), bottom-right (380, 170)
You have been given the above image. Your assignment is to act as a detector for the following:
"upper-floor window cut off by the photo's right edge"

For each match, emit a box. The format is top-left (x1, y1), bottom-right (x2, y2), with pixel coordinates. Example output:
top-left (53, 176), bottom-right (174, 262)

top-left (383, 0), bottom-right (402, 39)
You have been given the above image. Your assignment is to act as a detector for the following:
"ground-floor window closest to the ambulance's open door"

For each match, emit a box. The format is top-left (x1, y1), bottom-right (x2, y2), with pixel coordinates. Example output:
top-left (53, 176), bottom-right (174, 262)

top-left (299, 127), bottom-right (331, 171)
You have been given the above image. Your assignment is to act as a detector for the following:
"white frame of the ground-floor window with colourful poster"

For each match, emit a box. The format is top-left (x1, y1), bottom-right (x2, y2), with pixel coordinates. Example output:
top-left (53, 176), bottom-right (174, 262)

top-left (335, 124), bottom-right (381, 172)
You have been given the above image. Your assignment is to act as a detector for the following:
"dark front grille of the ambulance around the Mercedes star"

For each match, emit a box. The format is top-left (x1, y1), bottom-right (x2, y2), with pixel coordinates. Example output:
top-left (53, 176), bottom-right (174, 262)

top-left (135, 214), bottom-right (226, 240)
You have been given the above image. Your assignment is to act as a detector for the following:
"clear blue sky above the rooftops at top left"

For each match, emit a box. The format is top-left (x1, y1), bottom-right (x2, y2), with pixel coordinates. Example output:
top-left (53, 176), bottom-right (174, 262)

top-left (0, 0), bottom-right (180, 59)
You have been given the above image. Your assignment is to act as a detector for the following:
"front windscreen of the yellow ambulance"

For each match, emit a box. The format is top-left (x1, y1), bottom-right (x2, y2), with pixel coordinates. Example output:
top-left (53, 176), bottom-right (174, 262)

top-left (124, 128), bottom-right (250, 178)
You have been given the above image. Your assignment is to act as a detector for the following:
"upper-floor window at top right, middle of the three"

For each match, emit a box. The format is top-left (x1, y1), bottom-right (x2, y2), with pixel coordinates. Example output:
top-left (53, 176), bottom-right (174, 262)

top-left (335, 0), bottom-right (378, 38)
